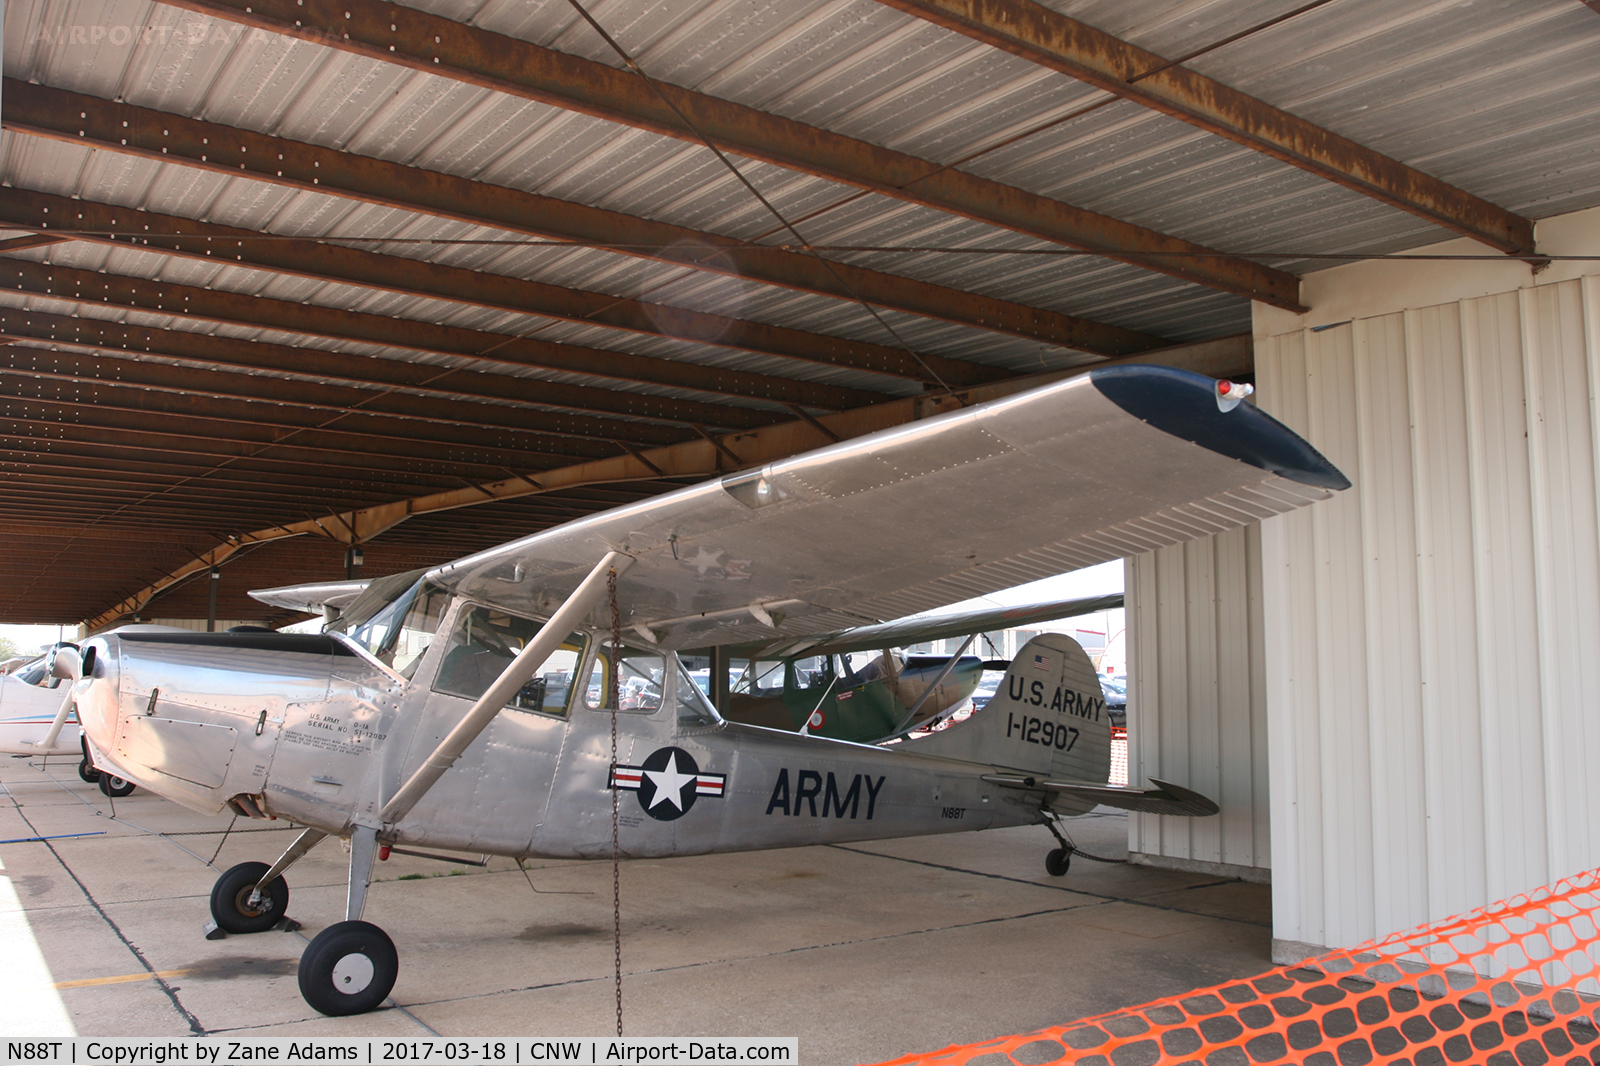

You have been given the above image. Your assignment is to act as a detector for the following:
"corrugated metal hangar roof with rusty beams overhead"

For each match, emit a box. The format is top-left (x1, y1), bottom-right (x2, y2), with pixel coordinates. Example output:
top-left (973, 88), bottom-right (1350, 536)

top-left (0, 0), bottom-right (1600, 624)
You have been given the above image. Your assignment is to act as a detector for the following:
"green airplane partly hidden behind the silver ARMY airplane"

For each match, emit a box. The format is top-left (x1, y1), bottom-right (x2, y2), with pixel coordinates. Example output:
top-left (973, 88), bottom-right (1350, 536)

top-left (707, 592), bottom-right (1123, 744)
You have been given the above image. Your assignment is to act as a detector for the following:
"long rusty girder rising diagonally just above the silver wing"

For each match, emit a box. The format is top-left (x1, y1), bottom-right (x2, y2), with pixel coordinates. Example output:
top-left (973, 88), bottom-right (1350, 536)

top-left (75, 336), bottom-right (1254, 627)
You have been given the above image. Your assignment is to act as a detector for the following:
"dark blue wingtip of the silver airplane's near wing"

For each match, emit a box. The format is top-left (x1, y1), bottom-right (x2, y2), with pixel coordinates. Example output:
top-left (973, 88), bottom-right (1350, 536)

top-left (1090, 363), bottom-right (1350, 490)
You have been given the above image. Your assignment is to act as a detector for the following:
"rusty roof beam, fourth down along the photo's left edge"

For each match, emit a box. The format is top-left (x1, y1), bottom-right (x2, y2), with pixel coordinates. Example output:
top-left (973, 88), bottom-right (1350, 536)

top-left (0, 307), bottom-right (768, 443)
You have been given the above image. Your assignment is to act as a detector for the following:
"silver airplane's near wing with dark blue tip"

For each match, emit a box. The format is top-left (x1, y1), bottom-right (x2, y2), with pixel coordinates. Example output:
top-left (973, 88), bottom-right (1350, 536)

top-left (429, 365), bottom-right (1349, 648)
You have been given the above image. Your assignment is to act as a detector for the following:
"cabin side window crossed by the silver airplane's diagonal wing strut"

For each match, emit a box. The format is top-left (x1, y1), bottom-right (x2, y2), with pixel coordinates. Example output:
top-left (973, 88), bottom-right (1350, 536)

top-left (434, 605), bottom-right (584, 714)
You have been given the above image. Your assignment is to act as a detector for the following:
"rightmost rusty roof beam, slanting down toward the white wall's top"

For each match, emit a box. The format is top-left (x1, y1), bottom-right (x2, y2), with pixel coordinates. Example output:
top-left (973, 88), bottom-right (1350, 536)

top-left (876, 0), bottom-right (1533, 254)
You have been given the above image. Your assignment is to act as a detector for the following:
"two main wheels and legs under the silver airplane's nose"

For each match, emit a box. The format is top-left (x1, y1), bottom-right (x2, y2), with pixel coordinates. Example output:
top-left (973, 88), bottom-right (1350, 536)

top-left (206, 828), bottom-right (400, 1016)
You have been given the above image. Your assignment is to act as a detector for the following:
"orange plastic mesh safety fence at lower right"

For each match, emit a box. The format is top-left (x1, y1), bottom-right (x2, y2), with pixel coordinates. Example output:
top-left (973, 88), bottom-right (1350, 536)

top-left (882, 871), bottom-right (1600, 1066)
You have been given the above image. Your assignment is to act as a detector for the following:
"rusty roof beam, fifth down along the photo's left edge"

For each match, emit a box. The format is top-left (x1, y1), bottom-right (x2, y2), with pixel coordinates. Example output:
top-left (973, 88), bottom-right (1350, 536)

top-left (0, 344), bottom-right (675, 456)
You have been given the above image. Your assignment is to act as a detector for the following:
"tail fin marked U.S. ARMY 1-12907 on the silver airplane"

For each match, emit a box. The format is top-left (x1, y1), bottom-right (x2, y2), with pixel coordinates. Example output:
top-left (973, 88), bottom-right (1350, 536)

top-left (902, 632), bottom-right (1110, 784)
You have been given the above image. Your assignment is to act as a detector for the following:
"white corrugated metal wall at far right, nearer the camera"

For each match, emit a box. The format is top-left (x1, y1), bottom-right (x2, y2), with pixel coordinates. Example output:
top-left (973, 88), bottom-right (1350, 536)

top-left (1248, 211), bottom-right (1600, 960)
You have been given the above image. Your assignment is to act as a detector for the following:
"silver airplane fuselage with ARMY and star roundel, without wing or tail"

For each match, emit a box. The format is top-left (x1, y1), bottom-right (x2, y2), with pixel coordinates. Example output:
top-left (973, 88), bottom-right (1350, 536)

top-left (78, 600), bottom-right (1107, 858)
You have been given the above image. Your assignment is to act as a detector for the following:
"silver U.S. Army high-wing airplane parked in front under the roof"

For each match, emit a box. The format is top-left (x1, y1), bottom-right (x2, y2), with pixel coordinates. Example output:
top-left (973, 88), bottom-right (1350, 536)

top-left (58, 365), bottom-right (1349, 1015)
